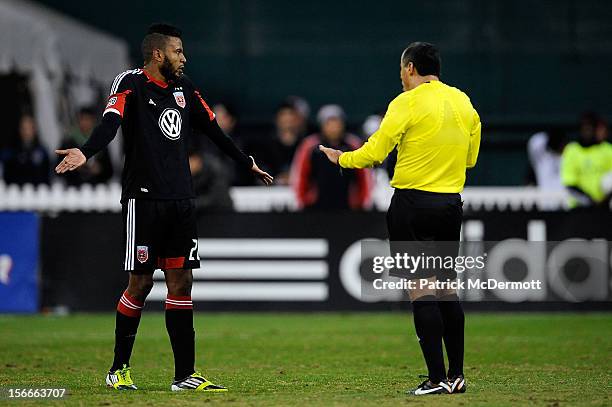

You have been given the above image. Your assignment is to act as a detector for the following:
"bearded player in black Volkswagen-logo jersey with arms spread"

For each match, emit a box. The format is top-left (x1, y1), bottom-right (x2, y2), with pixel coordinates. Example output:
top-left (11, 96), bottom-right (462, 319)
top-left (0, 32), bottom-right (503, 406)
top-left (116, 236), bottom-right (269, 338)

top-left (56, 24), bottom-right (273, 392)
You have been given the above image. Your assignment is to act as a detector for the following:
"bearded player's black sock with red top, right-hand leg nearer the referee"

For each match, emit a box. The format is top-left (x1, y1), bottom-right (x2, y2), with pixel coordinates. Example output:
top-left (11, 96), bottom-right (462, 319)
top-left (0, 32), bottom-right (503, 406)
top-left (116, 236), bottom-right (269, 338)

top-left (166, 295), bottom-right (195, 380)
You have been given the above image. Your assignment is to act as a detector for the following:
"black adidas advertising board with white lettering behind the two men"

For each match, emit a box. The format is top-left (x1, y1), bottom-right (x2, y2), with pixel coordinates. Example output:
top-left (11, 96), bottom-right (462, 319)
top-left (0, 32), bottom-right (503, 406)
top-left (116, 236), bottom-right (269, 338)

top-left (43, 212), bottom-right (612, 310)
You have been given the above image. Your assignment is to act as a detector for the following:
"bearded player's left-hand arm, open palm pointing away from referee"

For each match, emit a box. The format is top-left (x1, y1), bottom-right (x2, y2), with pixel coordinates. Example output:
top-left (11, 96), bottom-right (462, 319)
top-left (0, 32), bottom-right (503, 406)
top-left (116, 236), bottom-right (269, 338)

top-left (55, 75), bottom-right (132, 174)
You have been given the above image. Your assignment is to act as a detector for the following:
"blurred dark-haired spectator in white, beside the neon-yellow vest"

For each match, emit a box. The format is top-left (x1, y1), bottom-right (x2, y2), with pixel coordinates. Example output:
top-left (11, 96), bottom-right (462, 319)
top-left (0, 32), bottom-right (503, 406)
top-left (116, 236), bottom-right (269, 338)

top-left (527, 129), bottom-right (567, 190)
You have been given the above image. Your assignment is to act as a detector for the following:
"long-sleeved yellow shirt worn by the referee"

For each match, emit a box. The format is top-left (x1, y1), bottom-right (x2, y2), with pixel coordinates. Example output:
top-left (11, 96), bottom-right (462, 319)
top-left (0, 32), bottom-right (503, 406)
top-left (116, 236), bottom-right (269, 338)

top-left (339, 81), bottom-right (480, 193)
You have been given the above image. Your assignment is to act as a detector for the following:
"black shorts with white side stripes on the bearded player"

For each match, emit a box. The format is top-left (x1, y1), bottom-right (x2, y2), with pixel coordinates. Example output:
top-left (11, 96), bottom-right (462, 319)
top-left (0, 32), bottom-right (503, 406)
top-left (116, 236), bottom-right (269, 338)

top-left (122, 199), bottom-right (200, 274)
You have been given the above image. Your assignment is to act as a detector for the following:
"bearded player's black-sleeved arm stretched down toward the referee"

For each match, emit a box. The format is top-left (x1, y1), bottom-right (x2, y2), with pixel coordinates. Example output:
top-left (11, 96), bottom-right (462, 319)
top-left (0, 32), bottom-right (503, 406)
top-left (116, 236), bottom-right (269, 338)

top-left (191, 90), bottom-right (274, 185)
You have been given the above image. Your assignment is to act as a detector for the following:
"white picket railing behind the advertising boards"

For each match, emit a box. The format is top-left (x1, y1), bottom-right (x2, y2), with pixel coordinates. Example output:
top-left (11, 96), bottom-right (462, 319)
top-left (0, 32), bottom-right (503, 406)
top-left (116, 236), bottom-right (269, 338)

top-left (0, 181), bottom-right (568, 212)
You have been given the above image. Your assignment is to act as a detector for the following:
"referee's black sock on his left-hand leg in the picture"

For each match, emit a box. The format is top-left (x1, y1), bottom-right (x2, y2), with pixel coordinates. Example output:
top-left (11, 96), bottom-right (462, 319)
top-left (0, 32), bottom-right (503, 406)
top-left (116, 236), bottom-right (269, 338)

top-left (412, 295), bottom-right (446, 383)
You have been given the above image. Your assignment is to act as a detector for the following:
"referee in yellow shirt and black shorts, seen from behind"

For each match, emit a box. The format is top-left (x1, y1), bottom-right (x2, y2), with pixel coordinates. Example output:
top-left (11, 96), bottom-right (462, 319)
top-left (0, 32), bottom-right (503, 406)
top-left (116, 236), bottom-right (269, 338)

top-left (320, 42), bottom-right (481, 395)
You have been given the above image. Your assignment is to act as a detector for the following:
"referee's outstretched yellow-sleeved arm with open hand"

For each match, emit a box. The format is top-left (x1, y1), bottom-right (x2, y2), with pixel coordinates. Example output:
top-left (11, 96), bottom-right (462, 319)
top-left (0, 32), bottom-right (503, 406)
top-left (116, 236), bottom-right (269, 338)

top-left (319, 95), bottom-right (409, 168)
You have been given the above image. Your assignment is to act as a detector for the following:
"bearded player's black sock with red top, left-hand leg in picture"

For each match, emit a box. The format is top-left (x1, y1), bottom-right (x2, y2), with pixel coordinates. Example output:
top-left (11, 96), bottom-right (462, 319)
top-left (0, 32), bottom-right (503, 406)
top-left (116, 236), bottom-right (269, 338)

top-left (110, 290), bottom-right (144, 372)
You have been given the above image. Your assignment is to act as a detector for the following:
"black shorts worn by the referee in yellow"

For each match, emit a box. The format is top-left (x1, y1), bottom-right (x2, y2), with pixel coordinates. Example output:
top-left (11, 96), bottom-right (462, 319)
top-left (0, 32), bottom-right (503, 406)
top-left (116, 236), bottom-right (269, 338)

top-left (387, 189), bottom-right (463, 280)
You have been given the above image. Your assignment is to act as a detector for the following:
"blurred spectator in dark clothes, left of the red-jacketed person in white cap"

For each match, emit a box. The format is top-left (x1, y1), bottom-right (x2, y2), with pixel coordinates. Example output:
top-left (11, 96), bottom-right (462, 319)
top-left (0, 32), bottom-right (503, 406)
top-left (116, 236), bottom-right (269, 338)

top-left (247, 103), bottom-right (300, 185)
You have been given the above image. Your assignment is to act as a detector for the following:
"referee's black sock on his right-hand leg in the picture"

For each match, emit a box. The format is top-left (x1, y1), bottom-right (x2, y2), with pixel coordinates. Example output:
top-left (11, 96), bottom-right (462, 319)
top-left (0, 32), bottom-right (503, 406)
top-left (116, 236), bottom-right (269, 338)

top-left (438, 294), bottom-right (465, 377)
